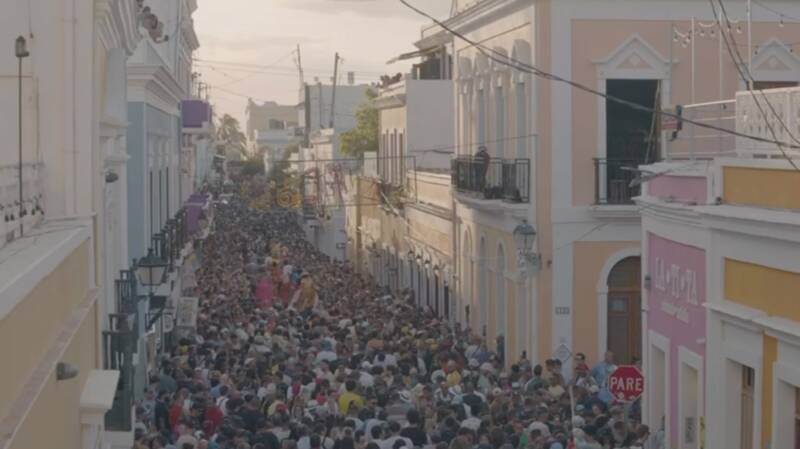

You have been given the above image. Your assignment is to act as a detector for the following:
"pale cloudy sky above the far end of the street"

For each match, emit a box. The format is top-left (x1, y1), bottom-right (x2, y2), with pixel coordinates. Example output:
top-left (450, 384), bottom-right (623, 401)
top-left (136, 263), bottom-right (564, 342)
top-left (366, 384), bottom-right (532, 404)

top-left (193, 0), bottom-right (451, 125)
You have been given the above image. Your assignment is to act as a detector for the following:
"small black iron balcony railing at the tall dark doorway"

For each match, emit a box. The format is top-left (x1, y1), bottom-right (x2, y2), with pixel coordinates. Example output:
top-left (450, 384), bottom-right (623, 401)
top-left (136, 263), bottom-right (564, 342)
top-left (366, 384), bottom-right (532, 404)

top-left (594, 158), bottom-right (641, 206)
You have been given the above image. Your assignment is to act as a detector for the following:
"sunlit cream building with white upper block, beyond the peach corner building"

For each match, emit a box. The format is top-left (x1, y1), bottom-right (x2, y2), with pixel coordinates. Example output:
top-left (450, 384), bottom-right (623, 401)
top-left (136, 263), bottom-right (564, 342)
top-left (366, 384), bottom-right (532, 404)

top-left (347, 30), bottom-right (458, 322)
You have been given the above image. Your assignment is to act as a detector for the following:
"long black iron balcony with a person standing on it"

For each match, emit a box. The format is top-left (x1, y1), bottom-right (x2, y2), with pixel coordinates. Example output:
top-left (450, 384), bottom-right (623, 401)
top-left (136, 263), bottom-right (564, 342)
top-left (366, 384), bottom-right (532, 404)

top-left (452, 156), bottom-right (530, 203)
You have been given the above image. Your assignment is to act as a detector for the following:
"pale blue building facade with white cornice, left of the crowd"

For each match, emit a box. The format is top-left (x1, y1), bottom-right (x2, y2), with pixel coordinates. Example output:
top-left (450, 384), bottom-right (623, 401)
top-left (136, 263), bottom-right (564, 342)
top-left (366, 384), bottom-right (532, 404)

top-left (126, 0), bottom-right (206, 406)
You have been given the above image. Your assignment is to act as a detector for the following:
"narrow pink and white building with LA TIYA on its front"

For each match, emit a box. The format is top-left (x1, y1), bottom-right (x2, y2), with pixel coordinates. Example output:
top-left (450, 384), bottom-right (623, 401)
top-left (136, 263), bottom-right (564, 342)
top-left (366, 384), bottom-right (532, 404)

top-left (640, 162), bottom-right (709, 448)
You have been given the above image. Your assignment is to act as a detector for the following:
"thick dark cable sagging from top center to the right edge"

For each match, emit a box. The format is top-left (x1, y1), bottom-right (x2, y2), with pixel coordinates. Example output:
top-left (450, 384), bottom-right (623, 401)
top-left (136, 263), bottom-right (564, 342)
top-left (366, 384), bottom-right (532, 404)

top-left (398, 0), bottom-right (800, 149)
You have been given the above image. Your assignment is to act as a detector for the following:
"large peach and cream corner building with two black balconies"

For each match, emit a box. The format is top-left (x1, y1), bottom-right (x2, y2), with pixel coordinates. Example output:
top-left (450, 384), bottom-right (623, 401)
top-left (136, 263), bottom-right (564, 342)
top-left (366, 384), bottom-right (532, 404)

top-left (444, 0), bottom-right (800, 370)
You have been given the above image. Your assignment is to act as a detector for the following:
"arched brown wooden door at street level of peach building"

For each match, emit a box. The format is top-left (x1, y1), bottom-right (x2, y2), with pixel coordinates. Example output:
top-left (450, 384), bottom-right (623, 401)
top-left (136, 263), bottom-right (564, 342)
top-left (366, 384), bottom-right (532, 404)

top-left (607, 256), bottom-right (642, 365)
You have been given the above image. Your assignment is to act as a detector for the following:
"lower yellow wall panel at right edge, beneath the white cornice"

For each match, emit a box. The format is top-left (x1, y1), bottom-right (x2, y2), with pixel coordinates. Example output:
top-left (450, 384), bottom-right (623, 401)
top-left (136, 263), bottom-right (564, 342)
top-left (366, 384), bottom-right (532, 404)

top-left (725, 255), bottom-right (800, 322)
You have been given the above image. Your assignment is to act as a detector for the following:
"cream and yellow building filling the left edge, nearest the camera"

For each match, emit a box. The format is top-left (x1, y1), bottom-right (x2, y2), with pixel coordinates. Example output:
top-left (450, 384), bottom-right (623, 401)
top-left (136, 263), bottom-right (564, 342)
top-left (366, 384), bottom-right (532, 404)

top-left (0, 0), bottom-right (147, 449)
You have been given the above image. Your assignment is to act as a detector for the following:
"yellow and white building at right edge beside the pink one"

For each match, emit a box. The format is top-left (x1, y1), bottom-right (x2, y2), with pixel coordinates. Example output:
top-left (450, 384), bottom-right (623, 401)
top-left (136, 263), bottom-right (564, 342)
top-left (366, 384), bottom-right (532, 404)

top-left (702, 156), bottom-right (800, 449)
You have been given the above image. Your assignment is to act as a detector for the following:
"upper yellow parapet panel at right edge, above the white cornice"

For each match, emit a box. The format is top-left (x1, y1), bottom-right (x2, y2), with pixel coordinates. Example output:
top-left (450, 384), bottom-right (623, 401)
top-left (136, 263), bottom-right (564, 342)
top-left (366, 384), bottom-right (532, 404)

top-left (723, 167), bottom-right (800, 209)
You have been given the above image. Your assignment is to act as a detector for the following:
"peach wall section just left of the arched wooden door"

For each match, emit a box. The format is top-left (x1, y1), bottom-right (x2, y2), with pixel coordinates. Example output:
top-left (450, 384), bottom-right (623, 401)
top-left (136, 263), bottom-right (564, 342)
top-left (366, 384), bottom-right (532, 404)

top-left (572, 242), bottom-right (639, 361)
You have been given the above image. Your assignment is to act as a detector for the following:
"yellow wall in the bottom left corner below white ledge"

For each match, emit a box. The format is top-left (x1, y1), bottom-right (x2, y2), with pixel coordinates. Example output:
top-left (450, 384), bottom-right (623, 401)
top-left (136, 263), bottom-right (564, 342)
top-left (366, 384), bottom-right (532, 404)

top-left (0, 242), bottom-right (100, 449)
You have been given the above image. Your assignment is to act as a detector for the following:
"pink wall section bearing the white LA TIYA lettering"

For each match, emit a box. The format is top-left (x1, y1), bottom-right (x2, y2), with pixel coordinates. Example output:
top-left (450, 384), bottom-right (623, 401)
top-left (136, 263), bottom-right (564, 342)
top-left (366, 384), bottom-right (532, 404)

top-left (647, 233), bottom-right (706, 442)
